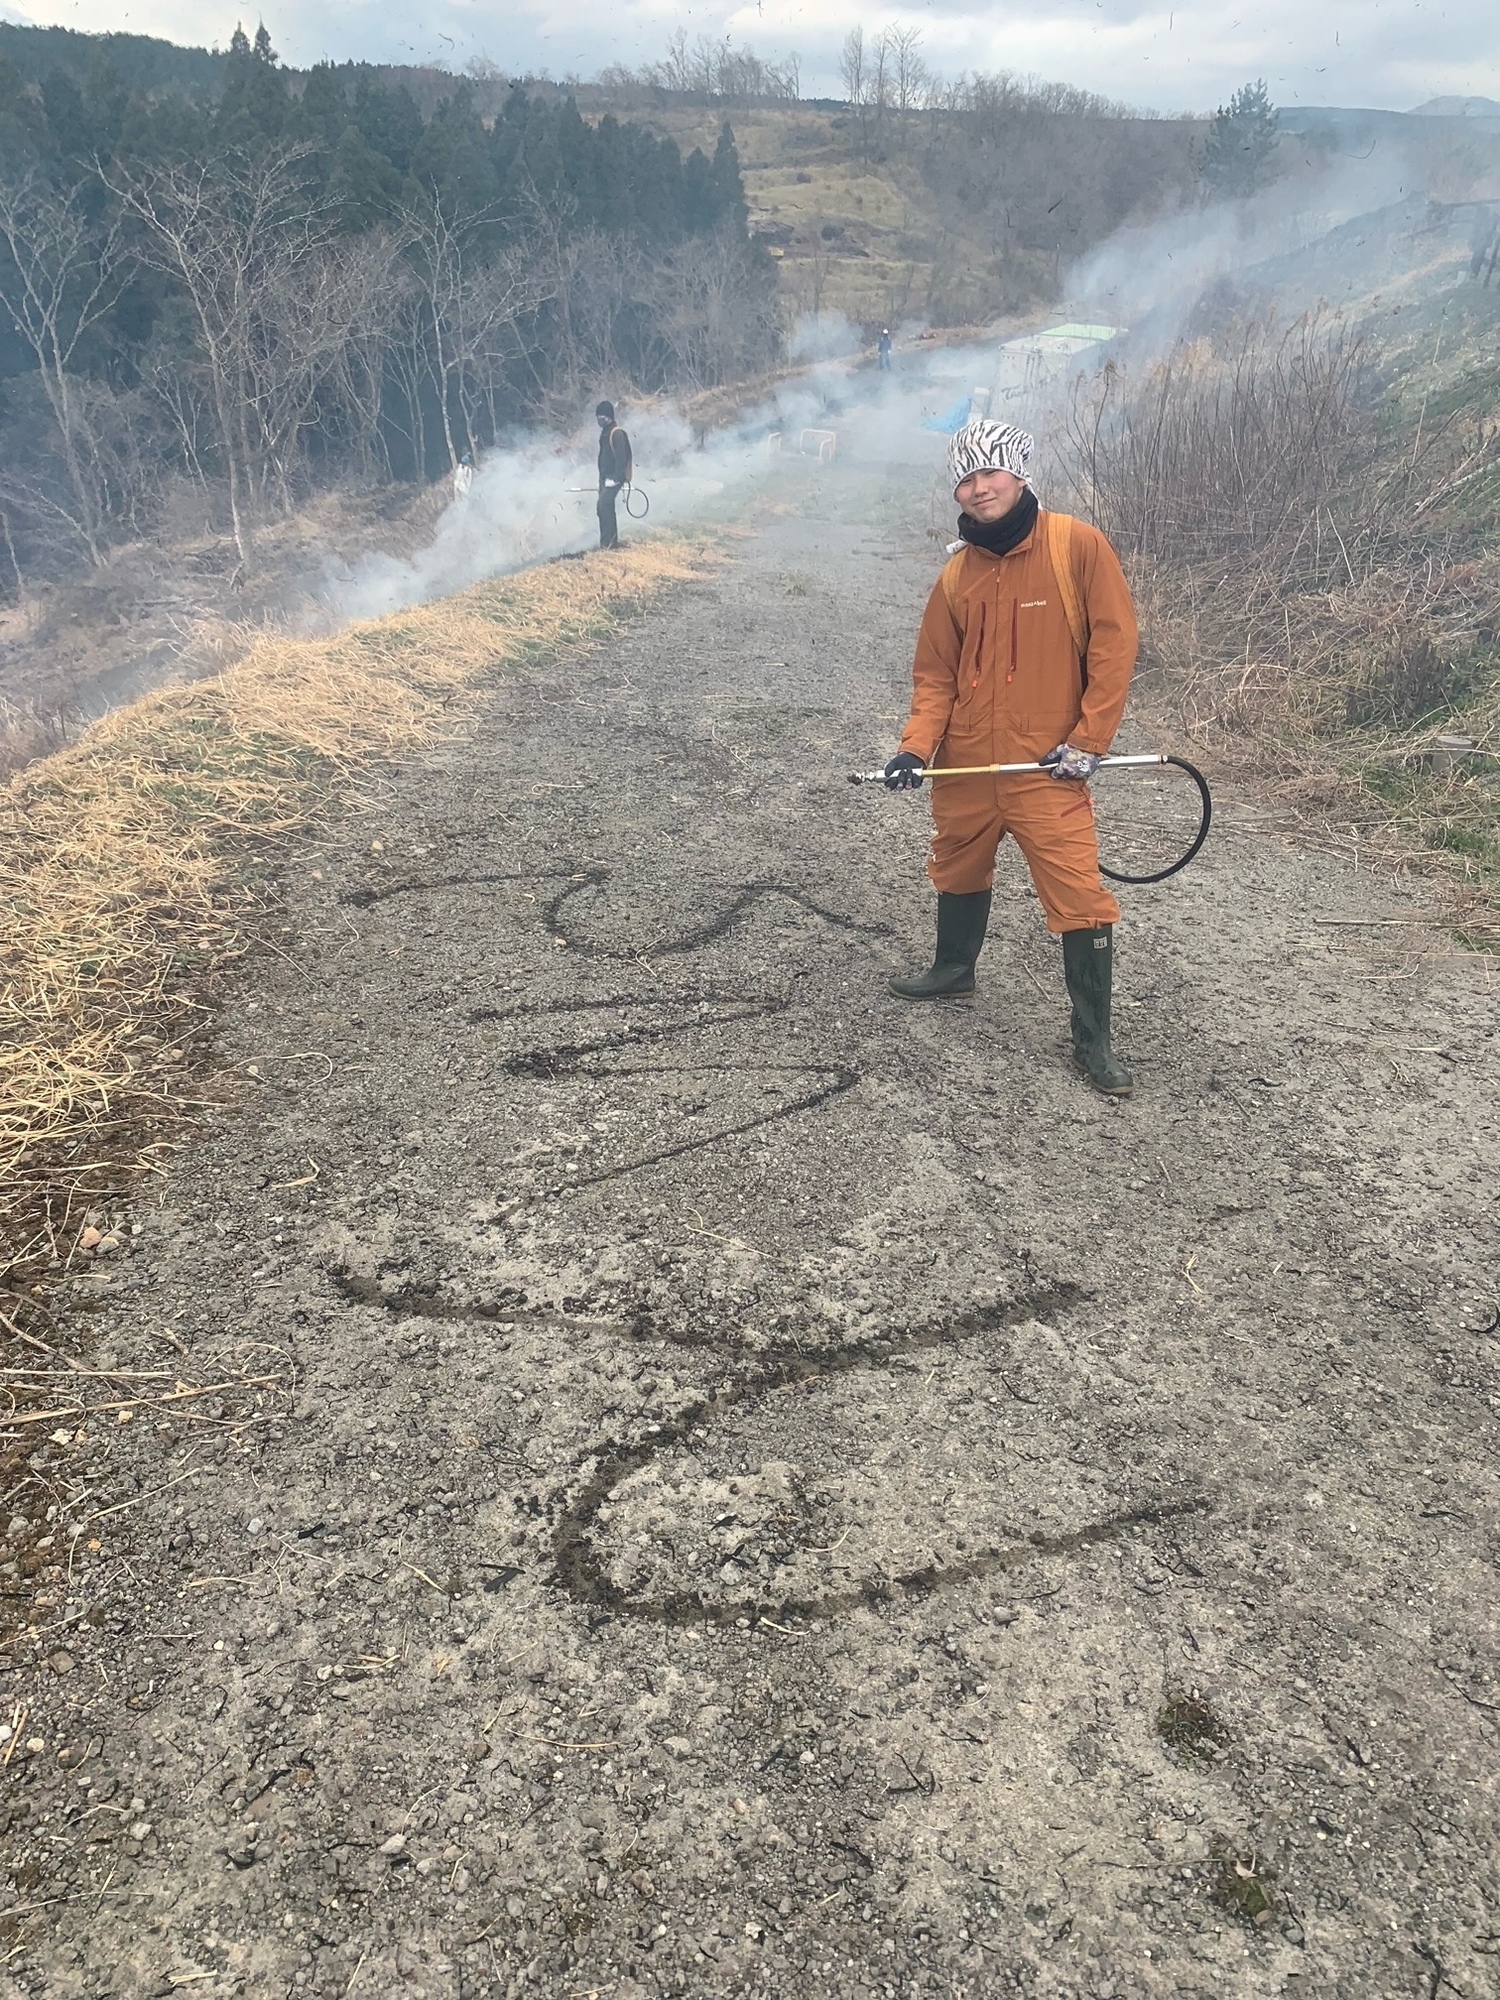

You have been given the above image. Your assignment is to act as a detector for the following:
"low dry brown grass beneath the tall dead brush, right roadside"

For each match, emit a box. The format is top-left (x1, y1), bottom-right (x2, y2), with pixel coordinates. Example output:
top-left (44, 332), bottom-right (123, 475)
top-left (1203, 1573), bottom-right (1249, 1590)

top-left (1134, 552), bottom-right (1500, 950)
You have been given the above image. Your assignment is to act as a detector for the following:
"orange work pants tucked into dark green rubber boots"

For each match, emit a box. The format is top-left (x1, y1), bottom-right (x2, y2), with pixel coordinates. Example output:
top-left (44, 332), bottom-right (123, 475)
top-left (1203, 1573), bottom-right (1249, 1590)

top-left (928, 774), bottom-right (1120, 936)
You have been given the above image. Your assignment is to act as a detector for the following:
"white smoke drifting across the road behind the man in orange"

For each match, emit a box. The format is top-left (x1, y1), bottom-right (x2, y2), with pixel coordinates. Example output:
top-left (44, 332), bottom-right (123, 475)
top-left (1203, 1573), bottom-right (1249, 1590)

top-left (322, 137), bottom-right (1496, 624)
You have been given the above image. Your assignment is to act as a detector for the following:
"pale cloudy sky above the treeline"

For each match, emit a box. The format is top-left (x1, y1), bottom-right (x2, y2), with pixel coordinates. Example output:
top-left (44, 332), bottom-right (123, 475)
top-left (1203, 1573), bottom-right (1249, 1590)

top-left (11, 0), bottom-right (1500, 112)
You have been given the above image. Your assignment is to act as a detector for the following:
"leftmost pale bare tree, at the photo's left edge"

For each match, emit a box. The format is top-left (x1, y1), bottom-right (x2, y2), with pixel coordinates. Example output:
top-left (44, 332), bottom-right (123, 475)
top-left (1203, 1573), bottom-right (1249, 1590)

top-left (0, 168), bottom-right (132, 564)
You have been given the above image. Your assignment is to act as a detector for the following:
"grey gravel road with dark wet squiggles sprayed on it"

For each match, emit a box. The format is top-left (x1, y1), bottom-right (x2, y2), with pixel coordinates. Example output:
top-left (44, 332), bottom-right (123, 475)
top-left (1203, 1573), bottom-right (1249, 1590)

top-left (11, 468), bottom-right (1500, 2000)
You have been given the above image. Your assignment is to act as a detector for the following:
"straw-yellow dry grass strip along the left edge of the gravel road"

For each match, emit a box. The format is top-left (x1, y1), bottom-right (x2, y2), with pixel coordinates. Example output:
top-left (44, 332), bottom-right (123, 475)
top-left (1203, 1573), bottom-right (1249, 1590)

top-left (0, 538), bottom-right (706, 1332)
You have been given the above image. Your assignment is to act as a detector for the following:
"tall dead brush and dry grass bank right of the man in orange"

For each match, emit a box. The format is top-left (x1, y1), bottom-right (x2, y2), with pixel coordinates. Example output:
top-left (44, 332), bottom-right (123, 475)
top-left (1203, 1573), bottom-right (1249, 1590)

top-left (1070, 316), bottom-right (1500, 944)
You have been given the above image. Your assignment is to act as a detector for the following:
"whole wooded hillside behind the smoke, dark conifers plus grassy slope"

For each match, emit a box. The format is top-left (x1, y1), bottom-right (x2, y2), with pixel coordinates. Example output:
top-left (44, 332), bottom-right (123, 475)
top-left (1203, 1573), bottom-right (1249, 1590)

top-left (0, 24), bottom-right (1336, 596)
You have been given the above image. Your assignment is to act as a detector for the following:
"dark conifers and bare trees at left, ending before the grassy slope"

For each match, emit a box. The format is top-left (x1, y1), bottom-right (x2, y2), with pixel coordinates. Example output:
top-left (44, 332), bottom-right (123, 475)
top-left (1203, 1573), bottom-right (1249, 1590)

top-left (0, 28), bottom-right (778, 588)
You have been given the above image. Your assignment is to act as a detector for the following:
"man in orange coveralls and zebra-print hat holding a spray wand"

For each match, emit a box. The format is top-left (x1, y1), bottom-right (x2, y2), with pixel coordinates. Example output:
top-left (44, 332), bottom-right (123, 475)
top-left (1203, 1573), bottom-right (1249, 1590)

top-left (884, 418), bottom-right (1136, 1096)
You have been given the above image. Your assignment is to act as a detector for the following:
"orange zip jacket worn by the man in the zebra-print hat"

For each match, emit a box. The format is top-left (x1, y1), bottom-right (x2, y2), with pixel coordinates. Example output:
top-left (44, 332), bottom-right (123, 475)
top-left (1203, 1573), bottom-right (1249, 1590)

top-left (900, 514), bottom-right (1138, 764)
